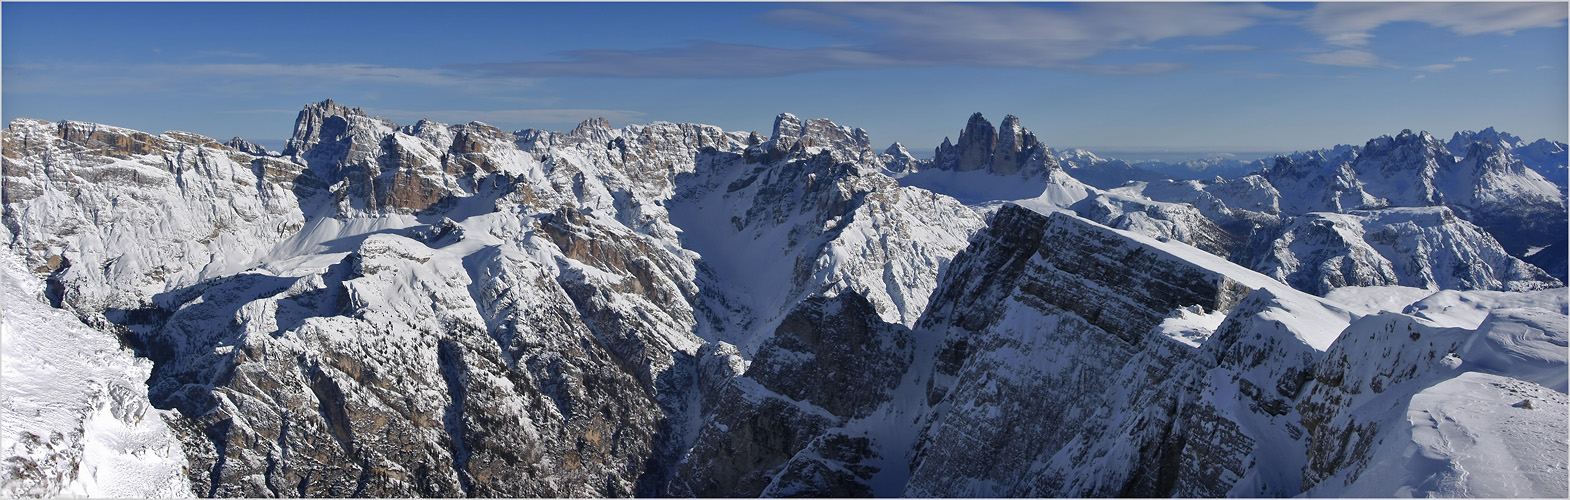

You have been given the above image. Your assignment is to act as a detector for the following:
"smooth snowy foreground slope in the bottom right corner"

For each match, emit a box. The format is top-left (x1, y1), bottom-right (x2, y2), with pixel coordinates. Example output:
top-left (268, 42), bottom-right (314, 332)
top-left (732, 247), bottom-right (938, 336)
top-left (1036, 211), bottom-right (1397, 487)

top-left (1300, 291), bottom-right (1570, 497)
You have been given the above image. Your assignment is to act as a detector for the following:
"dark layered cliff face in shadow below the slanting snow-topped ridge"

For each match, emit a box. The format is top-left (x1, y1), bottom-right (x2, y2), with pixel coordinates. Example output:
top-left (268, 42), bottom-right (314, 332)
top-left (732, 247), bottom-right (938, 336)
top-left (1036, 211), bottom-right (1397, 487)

top-left (906, 208), bottom-right (1306, 495)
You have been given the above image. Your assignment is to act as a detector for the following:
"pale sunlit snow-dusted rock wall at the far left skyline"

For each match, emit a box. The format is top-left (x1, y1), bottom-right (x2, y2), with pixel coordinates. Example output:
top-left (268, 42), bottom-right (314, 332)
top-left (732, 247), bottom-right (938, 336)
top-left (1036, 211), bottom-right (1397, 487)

top-left (0, 119), bottom-right (311, 316)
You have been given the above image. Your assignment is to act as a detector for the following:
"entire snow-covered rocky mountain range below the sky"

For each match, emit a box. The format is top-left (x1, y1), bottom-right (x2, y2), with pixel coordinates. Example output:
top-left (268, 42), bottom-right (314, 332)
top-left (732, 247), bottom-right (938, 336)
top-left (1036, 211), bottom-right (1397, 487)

top-left (0, 101), bottom-right (1570, 497)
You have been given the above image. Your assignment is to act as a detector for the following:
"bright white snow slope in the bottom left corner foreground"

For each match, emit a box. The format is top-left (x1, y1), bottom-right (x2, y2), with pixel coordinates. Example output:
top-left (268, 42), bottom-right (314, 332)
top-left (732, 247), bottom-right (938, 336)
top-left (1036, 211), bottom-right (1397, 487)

top-left (0, 238), bottom-right (192, 497)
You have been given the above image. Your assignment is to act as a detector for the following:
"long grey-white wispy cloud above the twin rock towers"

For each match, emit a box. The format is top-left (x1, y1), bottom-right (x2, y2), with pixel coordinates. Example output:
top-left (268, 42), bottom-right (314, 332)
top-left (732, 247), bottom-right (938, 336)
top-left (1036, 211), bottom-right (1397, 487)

top-left (451, 3), bottom-right (1295, 77)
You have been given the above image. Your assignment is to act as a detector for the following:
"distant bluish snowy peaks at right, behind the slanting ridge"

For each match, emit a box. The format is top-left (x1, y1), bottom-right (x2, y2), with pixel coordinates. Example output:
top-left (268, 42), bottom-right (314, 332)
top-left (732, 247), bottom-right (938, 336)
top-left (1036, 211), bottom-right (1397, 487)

top-left (900, 115), bottom-right (1567, 294)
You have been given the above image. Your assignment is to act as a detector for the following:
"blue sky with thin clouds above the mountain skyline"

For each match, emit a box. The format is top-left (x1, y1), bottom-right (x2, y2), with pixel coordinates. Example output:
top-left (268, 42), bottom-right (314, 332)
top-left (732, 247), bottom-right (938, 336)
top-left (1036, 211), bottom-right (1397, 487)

top-left (0, 2), bottom-right (1570, 154)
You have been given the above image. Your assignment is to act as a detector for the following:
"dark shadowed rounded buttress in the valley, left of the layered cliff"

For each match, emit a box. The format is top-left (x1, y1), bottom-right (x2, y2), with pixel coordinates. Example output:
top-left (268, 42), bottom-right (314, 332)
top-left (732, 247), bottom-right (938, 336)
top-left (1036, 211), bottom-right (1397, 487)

top-left (672, 292), bottom-right (912, 497)
